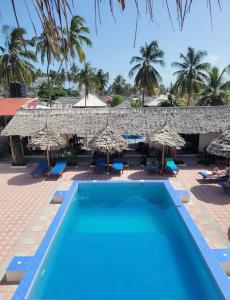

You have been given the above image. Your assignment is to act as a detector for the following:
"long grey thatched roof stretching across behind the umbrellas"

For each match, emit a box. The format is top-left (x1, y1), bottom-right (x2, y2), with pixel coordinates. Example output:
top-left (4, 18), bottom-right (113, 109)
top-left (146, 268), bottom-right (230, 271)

top-left (2, 106), bottom-right (230, 136)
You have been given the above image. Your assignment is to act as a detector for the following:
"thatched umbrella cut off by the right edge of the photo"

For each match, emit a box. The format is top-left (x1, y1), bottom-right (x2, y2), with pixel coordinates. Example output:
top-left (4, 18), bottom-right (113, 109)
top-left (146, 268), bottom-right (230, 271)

top-left (207, 129), bottom-right (230, 158)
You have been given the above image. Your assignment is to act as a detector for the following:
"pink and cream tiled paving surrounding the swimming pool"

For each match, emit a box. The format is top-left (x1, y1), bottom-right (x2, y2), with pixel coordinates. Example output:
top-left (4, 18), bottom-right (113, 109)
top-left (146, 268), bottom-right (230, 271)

top-left (0, 163), bottom-right (230, 300)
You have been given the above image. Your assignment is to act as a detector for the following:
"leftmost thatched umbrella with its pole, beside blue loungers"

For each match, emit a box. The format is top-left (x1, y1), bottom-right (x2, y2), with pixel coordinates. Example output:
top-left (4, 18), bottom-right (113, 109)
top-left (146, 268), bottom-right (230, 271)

top-left (28, 128), bottom-right (66, 167)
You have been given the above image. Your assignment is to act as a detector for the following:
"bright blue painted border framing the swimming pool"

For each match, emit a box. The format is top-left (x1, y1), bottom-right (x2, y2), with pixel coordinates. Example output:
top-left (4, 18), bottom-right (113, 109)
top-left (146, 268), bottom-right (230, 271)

top-left (12, 179), bottom-right (230, 300)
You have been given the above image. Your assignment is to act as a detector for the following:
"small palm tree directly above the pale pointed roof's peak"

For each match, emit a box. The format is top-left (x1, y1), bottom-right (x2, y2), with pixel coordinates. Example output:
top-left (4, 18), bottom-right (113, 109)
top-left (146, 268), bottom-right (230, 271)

top-left (76, 63), bottom-right (98, 106)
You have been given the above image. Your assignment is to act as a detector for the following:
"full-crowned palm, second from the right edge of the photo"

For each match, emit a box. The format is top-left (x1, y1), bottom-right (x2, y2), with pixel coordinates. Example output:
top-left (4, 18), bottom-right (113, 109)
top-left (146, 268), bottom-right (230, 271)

top-left (172, 47), bottom-right (209, 107)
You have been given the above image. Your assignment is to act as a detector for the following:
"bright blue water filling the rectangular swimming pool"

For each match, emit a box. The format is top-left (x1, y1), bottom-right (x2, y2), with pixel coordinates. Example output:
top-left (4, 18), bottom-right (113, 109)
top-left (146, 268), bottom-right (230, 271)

top-left (28, 183), bottom-right (225, 300)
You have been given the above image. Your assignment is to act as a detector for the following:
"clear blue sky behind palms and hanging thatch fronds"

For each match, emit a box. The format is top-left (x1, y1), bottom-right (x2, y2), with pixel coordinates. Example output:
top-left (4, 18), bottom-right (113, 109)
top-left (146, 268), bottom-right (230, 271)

top-left (0, 0), bottom-right (230, 86)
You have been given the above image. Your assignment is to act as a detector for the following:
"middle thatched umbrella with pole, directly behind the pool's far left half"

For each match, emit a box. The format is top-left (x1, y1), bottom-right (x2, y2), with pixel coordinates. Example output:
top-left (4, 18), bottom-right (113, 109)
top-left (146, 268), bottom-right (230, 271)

top-left (89, 126), bottom-right (128, 169)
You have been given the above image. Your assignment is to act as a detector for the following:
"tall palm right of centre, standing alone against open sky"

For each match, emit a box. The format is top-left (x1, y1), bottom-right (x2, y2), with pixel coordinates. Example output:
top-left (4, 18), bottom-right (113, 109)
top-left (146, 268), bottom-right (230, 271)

top-left (129, 41), bottom-right (164, 105)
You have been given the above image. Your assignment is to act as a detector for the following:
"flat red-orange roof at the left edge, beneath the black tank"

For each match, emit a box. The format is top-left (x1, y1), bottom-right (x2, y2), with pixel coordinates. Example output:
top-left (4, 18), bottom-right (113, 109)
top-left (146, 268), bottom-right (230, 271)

top-left (0, 98), bottom-right (30, 116)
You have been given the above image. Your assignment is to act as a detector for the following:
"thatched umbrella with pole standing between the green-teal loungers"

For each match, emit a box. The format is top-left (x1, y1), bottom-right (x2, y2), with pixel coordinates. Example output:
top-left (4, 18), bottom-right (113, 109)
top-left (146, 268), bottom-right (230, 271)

top-left (146, 125), bottom-right (185, 170)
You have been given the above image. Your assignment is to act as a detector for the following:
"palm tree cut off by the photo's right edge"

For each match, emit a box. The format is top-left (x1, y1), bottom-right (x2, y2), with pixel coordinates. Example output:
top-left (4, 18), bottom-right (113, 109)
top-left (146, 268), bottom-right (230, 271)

top-left (196, 66), bottom-right (230, 106)
